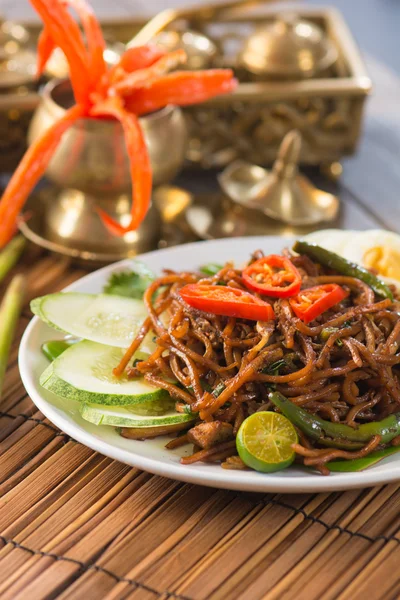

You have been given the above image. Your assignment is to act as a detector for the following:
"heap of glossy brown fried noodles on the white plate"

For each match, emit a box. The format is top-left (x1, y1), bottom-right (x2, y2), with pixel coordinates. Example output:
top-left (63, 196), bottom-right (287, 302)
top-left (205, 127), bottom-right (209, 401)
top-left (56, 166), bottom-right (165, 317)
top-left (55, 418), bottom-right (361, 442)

top-left (114, 248), bottom-right (400, 473)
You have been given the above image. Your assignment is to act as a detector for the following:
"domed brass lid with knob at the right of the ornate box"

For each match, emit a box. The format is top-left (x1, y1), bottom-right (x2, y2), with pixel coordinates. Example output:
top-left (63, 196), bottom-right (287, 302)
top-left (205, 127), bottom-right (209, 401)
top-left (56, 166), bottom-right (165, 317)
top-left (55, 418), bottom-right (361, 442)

top-left (241, 13), bottom-right (337, 79)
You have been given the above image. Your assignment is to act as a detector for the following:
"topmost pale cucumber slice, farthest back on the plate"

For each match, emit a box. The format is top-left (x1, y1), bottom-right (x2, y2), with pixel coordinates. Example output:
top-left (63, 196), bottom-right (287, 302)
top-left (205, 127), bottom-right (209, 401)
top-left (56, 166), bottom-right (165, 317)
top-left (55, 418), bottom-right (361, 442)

top-left (31, 292), bottom-right (155, 353)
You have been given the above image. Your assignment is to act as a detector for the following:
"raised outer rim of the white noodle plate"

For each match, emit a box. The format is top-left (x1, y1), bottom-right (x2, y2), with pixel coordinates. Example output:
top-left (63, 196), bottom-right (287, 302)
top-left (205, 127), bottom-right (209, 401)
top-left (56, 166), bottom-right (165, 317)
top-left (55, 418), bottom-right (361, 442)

top-left (18, 236), bottom-right (400, 493)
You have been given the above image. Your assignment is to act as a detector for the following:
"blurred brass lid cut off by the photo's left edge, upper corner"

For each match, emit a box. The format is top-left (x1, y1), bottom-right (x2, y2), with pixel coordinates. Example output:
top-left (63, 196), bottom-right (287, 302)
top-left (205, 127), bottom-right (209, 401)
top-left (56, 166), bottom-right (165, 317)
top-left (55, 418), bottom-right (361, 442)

top-left (0, 19), bottom-right (36, 90)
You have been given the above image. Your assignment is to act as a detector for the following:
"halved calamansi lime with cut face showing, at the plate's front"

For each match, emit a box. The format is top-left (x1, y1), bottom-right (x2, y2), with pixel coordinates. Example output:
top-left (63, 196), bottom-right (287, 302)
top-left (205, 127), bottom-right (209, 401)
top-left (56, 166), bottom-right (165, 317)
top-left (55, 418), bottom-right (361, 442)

top-left (236, 411), bottom-right (298, 473)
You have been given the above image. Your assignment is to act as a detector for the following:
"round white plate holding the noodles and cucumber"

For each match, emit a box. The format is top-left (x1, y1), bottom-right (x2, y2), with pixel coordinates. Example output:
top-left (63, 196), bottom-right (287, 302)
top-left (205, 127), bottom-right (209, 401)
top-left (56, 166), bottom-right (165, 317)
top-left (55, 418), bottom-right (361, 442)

top-left (19, 237), bottom-right (400, 493)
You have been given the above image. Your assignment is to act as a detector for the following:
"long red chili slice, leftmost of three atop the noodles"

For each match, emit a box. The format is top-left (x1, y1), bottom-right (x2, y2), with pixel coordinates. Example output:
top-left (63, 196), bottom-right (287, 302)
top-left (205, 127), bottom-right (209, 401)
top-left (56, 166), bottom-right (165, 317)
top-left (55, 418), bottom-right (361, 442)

top-left (180, 283), bottom-right (275, 321)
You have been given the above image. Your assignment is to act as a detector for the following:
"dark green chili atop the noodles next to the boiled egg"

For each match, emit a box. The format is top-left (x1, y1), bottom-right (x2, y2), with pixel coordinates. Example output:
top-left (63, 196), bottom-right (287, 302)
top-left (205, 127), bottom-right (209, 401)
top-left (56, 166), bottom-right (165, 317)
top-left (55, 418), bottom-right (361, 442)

top-left (293, 240), bottom-right (393, 300)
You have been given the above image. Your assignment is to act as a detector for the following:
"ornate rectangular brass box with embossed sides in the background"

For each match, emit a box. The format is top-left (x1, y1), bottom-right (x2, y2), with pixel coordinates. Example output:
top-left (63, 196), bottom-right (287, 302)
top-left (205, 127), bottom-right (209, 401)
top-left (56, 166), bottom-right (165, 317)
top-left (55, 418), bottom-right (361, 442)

top-left (177, 7), bottom-right (371, 167)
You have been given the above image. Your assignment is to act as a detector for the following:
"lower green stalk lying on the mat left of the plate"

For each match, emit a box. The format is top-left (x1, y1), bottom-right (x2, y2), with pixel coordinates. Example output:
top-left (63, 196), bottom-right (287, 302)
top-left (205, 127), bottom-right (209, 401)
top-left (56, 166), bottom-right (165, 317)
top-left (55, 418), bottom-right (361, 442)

top-left (0, 275), bottom-right (25, 397)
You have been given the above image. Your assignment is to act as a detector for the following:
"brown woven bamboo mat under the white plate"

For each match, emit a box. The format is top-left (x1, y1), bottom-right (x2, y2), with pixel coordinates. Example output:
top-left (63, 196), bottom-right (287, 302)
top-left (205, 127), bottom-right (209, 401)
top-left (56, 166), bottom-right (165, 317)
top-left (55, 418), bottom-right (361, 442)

top-left (0, 249), bottom-right (400, 600)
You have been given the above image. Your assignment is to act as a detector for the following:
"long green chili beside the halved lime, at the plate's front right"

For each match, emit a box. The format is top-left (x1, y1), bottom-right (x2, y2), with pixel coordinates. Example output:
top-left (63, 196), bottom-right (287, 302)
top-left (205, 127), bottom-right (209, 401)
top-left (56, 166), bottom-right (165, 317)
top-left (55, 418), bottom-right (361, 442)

top-left (268, 392), bottom-right (400, 449)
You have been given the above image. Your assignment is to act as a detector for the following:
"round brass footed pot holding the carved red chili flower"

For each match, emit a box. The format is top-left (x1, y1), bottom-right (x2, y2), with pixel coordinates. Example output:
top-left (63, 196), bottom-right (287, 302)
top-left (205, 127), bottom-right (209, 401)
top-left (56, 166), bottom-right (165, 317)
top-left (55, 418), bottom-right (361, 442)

top-left (28, 80), bottom-right (187, 258)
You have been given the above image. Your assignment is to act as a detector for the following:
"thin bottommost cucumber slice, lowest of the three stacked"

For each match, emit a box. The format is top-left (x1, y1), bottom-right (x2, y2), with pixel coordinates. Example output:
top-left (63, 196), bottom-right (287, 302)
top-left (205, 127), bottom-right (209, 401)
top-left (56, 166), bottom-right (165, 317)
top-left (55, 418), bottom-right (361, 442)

top-left (79, 403), bottom-right (196, 429)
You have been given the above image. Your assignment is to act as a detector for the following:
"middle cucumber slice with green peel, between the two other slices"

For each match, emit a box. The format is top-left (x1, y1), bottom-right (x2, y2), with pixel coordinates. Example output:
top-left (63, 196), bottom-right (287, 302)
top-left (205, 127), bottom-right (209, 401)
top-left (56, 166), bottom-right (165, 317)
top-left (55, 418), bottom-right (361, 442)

top-left (40, 340), bottom-right (174, 414)
